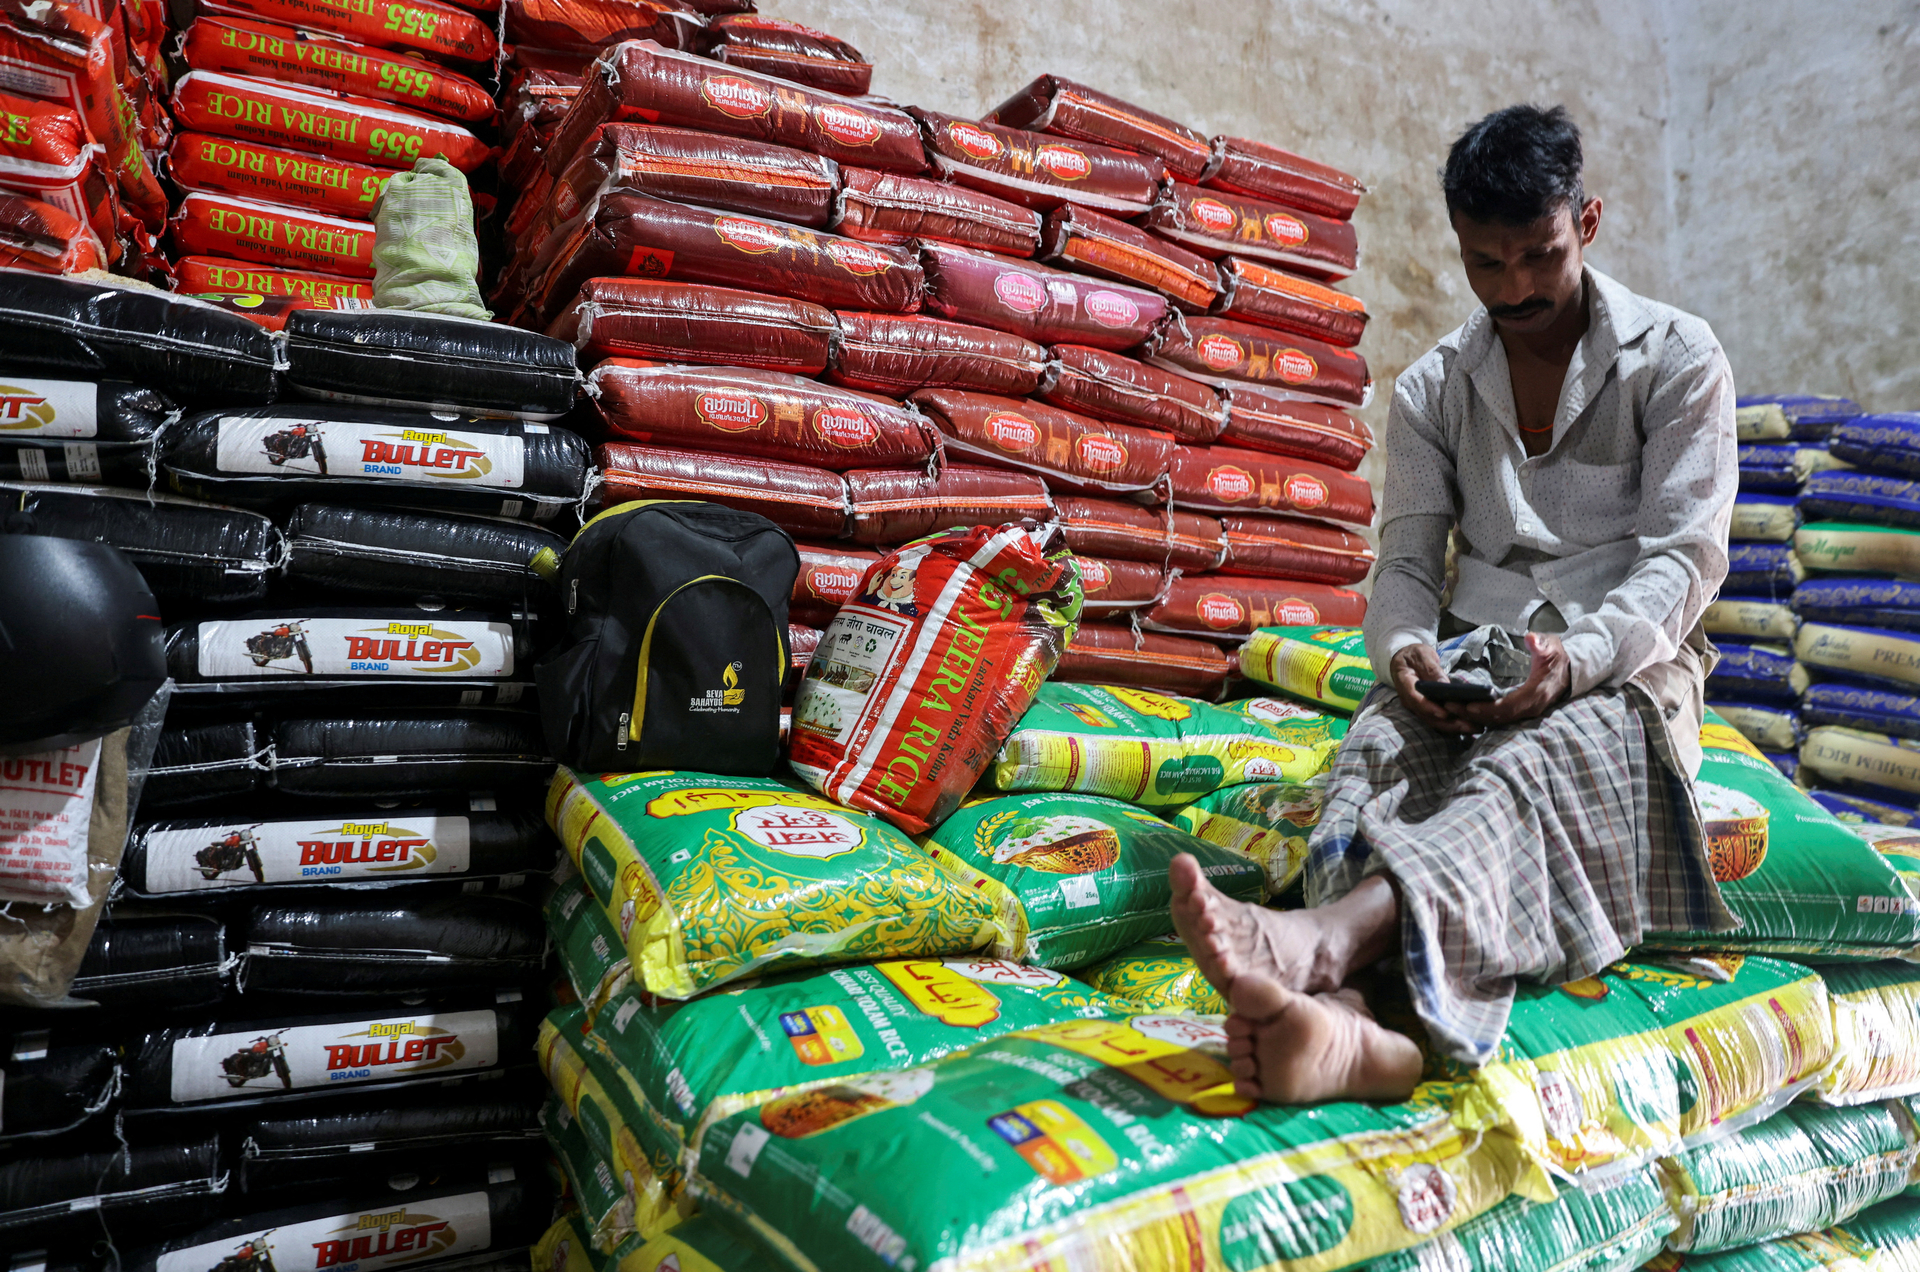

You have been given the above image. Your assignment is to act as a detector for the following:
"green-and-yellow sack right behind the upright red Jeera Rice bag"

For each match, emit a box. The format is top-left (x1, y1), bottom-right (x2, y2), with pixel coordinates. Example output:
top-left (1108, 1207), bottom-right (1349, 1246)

top-left (993, 682), bottom-right (1346, 807)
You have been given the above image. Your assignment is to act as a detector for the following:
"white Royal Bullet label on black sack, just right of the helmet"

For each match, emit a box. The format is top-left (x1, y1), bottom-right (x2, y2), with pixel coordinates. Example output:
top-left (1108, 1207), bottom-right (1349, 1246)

top-left (198, 617), bottom-right (513, 680)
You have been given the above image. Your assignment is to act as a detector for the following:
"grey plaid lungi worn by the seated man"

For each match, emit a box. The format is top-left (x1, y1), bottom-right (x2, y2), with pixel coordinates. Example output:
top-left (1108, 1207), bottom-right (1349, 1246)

top-left (1306, 628), bottom-right (1738, 1064)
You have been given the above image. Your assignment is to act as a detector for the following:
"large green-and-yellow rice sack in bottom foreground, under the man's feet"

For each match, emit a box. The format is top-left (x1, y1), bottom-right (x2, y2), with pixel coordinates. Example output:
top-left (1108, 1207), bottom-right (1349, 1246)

top-left (695, 1016), bottom-right (1519, 1272)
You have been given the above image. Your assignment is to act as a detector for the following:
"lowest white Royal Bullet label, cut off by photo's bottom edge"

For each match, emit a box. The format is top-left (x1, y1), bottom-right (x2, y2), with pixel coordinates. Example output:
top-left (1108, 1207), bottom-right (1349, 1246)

top-left (154, 1193), bottom-right (493, 1272)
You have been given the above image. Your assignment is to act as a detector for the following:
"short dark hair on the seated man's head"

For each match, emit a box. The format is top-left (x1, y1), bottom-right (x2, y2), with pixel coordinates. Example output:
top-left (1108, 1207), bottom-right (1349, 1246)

top-left (1440, 106), bottom-right (1586, 225)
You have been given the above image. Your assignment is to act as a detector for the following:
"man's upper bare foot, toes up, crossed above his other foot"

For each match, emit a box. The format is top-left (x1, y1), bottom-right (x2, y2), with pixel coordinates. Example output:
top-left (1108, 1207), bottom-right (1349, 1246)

top-left (1169, 853), bottom-right (1400, 995)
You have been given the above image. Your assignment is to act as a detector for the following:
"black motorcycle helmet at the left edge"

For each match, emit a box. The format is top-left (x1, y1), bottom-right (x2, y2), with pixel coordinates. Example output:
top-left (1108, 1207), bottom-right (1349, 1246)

top-left (0, 534), bottom-right (167, 753)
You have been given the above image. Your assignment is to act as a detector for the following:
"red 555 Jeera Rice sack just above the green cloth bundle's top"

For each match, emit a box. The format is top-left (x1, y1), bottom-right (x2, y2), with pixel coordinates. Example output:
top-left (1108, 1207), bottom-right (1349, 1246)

top-left (173, 71), bottom-right (493, 173)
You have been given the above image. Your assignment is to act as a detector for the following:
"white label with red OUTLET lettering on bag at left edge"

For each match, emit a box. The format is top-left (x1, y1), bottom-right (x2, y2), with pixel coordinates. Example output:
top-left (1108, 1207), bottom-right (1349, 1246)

top-left (0, 738), bottom-right (100, 905)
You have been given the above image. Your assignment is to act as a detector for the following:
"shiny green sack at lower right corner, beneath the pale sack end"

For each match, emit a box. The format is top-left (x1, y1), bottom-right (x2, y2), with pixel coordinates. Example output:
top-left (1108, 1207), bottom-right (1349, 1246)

top-left (1659, 1101), bottom-right (1920, 1253)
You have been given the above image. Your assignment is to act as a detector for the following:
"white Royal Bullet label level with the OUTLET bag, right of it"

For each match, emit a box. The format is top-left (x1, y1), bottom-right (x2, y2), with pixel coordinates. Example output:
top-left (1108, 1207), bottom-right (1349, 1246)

top-left (146, 813), bottom-right (472, 893)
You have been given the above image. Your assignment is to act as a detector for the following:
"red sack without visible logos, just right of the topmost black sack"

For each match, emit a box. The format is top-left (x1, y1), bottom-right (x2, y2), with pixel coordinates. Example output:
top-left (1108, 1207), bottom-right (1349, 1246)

top-left (549, 279), bottom-right (835, 375)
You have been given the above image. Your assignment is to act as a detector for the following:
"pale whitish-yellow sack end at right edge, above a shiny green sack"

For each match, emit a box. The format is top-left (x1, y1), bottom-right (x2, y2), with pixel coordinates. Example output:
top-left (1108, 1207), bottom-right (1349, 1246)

top-left (1812, 961), bottom-right (1920, 1105)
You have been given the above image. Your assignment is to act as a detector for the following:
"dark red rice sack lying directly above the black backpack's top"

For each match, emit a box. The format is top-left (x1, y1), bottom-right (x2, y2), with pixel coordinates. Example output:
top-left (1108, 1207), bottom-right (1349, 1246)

top-left (593, 442), bottom-right (847, 538)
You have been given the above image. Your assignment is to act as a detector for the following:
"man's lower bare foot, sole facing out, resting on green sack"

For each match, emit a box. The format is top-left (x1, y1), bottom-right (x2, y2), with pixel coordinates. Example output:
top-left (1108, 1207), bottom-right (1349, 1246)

top-left (1227, 976), bottom-right (1421, 1105)
